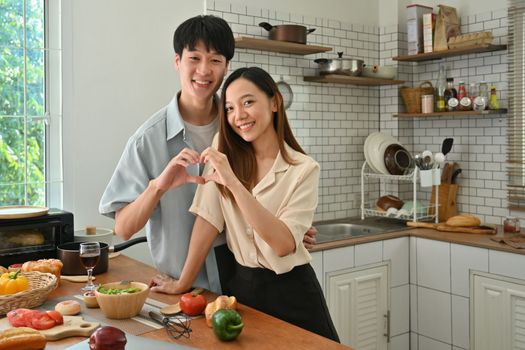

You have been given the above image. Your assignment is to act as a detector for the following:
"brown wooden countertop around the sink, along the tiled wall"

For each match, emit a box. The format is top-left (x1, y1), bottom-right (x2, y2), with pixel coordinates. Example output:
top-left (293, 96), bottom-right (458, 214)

top-left (311, 219), bottom-right (525, 254)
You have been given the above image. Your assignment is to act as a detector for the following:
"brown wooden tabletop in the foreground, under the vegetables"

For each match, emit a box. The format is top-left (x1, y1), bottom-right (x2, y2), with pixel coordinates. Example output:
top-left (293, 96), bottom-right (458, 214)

top-left (46, 255), bottom-right (350, 350)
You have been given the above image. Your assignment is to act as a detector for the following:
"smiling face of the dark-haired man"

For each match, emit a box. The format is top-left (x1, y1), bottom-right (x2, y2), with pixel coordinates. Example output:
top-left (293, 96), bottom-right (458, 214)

top-left (175, 41), bottom-right (228, 102)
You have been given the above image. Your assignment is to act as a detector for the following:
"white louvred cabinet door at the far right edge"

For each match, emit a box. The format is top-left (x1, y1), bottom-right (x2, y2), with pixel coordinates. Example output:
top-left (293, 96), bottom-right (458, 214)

top-left (471, 275), bottom-right (525, 350)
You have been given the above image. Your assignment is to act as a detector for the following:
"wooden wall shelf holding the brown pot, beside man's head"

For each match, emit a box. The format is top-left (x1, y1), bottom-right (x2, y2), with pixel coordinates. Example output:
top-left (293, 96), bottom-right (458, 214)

top-left (235, 36), bottom-right (332, 55)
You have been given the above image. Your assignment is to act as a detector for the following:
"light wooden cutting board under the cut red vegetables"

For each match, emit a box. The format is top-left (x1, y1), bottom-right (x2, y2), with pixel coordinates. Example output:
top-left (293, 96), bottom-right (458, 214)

top-left (0, 316), bottom-right (100, 341)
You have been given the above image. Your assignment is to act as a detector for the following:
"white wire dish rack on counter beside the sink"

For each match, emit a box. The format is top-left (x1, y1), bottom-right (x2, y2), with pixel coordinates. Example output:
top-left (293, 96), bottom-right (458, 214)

top-left (361, 161), bottom-right (439, 223)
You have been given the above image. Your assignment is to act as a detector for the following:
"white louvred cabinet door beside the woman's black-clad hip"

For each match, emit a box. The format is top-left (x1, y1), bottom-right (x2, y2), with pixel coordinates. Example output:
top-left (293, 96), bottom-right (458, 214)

top-left (325, 265), bottom-right (390, 350)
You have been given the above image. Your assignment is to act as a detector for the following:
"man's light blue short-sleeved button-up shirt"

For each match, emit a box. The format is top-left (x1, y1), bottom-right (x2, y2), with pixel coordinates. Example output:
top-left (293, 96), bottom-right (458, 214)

top-left (99, 97), bottom-right (225, 294)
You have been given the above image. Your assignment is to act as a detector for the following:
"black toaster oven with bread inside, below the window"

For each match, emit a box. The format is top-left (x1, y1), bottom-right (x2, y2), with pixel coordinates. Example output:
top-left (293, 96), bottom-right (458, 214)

top-left (0, 209), bottom-right (74, 267)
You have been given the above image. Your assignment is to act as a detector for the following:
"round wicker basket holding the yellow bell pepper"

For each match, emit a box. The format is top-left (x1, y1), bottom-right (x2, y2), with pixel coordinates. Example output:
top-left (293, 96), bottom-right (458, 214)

top-left (0, 271), bottom-right (58, 315)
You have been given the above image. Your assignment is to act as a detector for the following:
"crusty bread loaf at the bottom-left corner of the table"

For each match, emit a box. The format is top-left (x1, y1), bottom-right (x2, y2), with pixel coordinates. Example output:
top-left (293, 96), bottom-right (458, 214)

top-left (0, 327), bottom-right (46, 350)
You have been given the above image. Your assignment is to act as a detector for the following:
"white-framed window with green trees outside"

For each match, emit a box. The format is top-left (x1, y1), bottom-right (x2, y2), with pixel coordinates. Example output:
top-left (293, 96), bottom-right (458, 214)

top-left (0, 0), bottom-right (62, 206)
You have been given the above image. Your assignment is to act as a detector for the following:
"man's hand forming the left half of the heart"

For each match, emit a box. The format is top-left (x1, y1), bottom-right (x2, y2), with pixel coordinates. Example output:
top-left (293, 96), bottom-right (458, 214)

top-left (154, 148), bottom-right (205, 191)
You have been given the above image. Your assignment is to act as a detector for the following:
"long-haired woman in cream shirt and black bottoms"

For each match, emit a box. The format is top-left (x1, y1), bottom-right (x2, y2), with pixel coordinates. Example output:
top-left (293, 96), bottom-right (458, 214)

top-left (156, 67), bottom-right (339, 341)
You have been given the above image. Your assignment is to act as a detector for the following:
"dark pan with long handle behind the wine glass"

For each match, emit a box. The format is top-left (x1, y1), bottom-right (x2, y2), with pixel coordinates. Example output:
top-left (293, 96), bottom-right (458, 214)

top-left (57, 237), bottom-right (148, 276)
